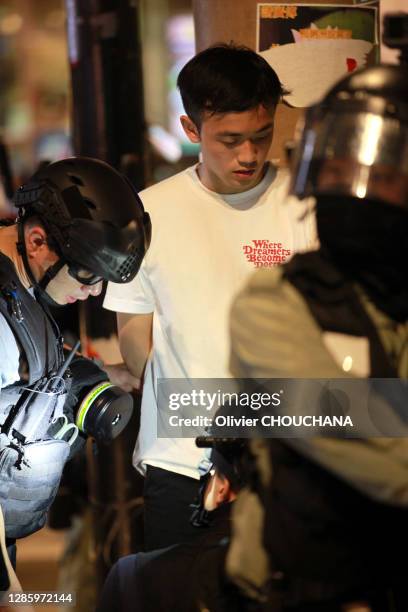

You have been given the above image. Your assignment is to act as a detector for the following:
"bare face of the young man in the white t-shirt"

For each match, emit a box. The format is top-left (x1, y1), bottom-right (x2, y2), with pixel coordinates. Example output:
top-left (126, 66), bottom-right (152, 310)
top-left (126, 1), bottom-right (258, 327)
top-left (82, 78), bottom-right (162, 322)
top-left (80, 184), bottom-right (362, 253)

top-left (181, 105), bottom-right (276, 194)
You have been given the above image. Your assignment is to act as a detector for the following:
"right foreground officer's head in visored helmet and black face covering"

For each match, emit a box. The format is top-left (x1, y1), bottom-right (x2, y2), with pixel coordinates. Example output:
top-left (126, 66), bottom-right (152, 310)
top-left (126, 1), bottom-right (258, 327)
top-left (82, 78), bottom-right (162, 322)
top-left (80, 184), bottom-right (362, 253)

top-left (290, 44), bottom-right (408, 322)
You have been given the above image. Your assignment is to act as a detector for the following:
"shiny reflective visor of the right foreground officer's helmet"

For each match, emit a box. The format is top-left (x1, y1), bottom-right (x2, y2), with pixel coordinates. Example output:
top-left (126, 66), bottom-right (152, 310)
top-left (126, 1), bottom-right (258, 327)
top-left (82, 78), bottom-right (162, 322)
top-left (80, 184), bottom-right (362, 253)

top-left (291, 113), bottom-right (408, 208)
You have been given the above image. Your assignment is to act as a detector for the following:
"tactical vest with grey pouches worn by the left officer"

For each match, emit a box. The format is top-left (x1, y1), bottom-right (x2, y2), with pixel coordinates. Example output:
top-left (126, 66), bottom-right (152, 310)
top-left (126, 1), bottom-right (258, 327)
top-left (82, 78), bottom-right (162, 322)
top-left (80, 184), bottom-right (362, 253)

top-left (0, 253), bottom-right (69, 538)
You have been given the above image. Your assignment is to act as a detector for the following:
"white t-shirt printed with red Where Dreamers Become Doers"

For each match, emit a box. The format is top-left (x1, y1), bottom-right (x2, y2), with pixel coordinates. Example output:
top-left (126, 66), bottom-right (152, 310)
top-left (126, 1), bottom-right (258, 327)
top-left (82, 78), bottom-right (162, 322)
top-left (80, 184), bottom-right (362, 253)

top-left (104, 165), bottom-right (315, 478)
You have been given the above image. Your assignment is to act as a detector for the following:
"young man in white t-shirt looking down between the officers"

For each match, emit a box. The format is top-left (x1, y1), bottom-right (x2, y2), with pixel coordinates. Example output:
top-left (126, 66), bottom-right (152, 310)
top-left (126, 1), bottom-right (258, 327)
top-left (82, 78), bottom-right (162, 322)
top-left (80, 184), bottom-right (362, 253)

top-left (104, 45), bottom-right (312, 549)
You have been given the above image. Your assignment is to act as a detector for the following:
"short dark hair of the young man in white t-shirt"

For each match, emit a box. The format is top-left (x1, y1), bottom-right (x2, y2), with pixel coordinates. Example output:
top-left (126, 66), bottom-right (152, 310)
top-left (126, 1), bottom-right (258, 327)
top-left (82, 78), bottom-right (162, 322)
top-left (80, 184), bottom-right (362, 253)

top-left (177, 44), bottom-right (285, 128)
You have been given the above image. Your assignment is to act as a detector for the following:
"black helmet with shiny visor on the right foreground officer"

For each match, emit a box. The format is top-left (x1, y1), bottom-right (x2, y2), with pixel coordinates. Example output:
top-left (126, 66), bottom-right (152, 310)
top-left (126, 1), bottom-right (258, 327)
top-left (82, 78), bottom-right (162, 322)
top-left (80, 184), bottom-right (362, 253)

top-left (290, 65), bottom-right (408, 208)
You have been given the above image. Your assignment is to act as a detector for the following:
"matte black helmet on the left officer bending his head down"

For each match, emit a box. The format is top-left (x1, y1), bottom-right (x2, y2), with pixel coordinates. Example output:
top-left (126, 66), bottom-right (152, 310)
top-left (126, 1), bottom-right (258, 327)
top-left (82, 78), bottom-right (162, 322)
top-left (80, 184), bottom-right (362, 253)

top-left (14, 157), bottom-right (151, 287)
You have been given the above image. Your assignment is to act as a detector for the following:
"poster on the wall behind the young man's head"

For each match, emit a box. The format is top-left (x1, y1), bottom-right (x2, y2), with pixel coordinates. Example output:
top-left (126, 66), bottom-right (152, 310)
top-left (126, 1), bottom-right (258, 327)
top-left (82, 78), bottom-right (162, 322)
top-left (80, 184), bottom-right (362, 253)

top-left (257, 0), bottom-right (379, 108)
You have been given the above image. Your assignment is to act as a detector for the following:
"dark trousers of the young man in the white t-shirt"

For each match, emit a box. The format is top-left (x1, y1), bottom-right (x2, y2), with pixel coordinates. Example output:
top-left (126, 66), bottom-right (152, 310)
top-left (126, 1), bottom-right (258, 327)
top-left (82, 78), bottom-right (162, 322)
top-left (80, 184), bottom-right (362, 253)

top-left (143, 465), bottom-right (201, 551)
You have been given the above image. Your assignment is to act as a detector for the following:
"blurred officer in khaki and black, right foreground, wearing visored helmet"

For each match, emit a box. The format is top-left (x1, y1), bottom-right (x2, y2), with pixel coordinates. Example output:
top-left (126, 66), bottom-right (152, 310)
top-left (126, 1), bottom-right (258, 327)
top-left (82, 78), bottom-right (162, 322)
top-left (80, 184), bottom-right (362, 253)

top-left (227, 14), bottom-right (408, 612)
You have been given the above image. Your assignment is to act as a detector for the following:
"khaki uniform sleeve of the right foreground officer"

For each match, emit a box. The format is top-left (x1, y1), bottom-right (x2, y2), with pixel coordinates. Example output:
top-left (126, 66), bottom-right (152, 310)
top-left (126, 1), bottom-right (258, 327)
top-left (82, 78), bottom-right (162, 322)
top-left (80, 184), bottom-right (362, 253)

top-left (230, 269), bottom-right (408, 506)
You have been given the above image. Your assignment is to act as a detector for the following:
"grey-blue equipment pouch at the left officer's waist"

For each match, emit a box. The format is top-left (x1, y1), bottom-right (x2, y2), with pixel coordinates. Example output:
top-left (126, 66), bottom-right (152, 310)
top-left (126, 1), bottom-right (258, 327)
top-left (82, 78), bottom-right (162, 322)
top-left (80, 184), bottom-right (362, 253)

top-left (0, 381), bottom-right (71, 538)
